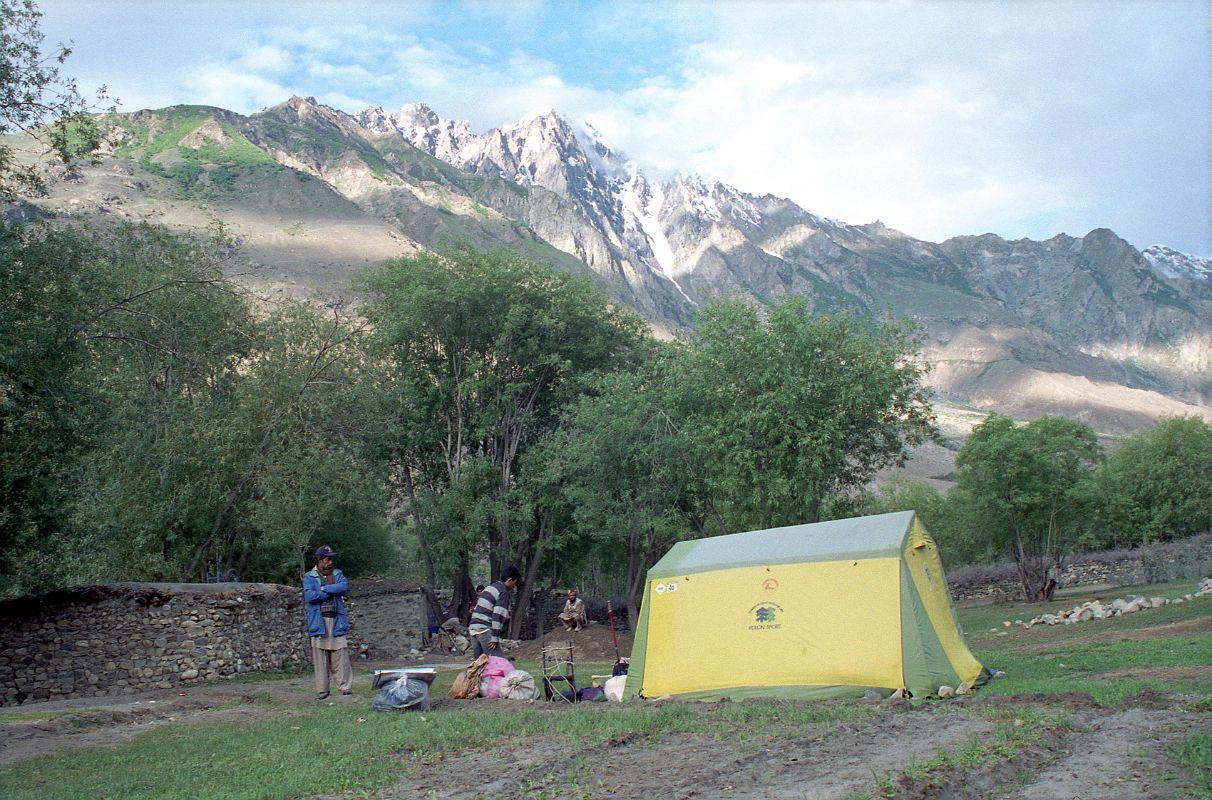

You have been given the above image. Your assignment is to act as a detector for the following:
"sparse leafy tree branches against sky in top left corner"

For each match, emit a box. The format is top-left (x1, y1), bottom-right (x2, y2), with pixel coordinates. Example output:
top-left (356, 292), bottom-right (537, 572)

top-left (0, 0), bottom-right (108, 198)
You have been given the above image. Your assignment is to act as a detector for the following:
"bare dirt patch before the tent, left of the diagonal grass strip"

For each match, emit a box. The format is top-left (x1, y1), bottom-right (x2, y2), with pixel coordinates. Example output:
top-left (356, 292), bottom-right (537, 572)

top-left (378, 709), bottom-right (991, 800)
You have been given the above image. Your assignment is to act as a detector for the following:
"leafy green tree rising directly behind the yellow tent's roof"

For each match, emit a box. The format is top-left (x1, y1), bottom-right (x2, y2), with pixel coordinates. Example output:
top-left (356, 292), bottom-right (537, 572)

top-left (675, 298), bottom-right (934, 530)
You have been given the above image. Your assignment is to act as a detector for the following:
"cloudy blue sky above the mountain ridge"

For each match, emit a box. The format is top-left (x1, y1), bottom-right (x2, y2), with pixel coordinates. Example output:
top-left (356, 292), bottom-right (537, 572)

top-left (40, 0), bottom-right (1212, 257)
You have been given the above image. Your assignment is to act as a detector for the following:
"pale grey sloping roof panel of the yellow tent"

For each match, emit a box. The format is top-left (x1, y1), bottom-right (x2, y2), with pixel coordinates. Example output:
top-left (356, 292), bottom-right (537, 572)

top-left (648, 512), bottom-right (914, 581)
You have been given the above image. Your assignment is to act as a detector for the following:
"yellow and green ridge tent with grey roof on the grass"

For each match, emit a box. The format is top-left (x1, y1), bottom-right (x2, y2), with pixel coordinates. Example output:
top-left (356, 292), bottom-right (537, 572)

top-left (627, 512), bottom-right (988, 699)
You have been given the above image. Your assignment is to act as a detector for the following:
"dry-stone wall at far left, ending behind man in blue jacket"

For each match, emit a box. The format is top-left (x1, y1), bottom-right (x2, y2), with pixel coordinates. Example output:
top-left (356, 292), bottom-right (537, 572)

top-left (0, 583), bottom-right (308, 705)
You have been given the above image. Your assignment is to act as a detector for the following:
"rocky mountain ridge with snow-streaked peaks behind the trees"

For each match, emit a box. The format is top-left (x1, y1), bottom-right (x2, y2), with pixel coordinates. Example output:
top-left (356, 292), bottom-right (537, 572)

top-left (11, 97), bottom-right (1212, 432)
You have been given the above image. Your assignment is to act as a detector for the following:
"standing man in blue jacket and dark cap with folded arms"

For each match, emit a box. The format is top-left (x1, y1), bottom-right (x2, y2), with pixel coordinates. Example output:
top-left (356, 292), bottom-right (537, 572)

top-left (303, 544), bottom-right (354, 699)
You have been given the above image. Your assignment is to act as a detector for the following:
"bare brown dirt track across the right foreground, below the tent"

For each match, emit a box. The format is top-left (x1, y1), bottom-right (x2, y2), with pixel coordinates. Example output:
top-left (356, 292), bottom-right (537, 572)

top-left (373, 695), bottom-right (1212, 800)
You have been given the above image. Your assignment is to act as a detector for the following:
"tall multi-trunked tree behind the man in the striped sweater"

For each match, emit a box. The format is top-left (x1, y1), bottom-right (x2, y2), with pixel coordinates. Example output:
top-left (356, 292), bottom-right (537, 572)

top-left (362, 245), bottom-right (642, 608)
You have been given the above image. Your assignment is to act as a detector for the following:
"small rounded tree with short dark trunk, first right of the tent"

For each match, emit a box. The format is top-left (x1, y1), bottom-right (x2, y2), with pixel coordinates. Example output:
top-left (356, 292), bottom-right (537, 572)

top-left (948, 415), bottom-right (1103, 601)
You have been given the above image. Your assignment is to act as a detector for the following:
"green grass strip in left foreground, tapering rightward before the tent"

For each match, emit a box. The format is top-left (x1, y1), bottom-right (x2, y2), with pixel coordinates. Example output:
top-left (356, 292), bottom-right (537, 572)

top-left (0, 692), bottom-right (875, 800)
